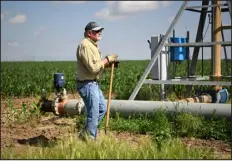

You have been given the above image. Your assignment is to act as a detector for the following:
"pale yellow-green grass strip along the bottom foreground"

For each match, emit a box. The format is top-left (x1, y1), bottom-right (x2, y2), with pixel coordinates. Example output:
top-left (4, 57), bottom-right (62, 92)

top-left (2, 134), bottom-right (216, 160)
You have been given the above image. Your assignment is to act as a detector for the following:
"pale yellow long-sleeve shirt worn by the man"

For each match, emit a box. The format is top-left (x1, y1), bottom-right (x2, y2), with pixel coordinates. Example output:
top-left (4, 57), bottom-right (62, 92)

top-left (76, 38), bottom-right (104, 80)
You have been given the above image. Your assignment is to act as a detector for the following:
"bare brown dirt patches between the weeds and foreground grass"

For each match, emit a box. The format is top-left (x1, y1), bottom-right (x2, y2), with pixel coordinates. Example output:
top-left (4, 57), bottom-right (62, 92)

top-left (1, 95), bottom-right (231, 158)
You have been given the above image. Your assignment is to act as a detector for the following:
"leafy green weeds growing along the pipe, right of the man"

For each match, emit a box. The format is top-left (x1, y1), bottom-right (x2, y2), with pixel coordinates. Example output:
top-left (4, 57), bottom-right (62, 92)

top-left (97, 109), bottom-right (231, 142)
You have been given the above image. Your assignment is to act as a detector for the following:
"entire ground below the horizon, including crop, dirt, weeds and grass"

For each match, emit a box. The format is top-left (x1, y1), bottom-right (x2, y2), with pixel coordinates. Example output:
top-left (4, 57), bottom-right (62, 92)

top-left (1, 60), bottom-right (232, 159)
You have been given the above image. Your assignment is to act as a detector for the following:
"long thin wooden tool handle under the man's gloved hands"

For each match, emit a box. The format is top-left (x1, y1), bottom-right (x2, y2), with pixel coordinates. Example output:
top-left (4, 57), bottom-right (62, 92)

top-left (105, 63), bottom-right (114, 134)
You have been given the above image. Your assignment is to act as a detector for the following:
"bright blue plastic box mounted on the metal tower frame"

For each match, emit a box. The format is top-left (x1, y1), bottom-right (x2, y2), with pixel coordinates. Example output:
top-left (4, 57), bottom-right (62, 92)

top-left (170, 37), bottom-right (187, 62)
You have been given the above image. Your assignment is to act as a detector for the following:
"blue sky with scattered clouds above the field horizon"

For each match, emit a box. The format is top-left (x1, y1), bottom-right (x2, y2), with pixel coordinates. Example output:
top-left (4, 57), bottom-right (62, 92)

top-left (1, 1), bottom-right (231, 61)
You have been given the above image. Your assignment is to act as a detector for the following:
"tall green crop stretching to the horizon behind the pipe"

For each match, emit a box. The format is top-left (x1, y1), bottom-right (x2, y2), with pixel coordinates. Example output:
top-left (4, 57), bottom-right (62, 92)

top-left (1, 60), bottom-right (231, 100)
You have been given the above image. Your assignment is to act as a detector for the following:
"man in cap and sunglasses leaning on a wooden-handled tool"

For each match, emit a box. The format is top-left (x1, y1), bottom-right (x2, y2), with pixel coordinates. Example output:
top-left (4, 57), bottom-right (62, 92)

top-left (76, 22), bottom-right (118, 139)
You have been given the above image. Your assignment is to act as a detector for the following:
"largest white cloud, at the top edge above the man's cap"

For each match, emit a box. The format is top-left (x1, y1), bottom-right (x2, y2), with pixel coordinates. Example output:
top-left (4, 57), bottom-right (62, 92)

top-left (95, 1), bottom-right (171, 20)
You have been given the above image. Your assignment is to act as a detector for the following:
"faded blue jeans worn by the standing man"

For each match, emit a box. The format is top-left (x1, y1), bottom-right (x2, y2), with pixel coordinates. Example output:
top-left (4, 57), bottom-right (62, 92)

top-left (77, 81), bottom-right (107, 139)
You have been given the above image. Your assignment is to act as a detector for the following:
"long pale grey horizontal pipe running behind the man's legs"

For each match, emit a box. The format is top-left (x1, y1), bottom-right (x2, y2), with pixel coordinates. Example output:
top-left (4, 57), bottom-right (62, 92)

top-left (64, 99), bottom-right (231, 117)
